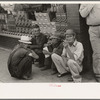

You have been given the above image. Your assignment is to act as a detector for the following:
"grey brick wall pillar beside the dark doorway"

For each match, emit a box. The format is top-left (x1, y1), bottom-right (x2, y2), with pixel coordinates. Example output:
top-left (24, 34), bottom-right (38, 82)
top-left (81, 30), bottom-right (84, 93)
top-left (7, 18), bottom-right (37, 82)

top-left (66, 4), bottom-right (81, 41)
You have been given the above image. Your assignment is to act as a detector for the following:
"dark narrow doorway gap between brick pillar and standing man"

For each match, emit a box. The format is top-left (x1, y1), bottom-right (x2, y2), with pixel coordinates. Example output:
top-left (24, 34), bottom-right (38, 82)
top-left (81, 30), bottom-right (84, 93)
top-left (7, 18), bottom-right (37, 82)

top-left (79, 15), bottom-right (93, 72)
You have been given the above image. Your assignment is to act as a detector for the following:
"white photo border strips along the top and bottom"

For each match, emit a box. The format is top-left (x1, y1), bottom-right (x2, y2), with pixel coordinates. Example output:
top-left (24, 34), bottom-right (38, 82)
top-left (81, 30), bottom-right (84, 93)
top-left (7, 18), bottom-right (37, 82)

top-left (0, 1), bottom-right (100, 100)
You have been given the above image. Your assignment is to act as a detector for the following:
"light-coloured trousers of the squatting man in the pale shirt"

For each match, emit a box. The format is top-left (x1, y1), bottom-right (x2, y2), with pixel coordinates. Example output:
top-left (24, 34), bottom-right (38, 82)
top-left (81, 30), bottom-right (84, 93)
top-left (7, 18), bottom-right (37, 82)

top-left (51, 53), bottom-right (82, 82)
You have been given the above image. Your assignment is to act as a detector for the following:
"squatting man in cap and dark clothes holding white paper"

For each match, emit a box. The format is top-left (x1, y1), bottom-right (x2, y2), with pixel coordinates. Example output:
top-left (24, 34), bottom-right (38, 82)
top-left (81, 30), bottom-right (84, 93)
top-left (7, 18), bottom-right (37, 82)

top-left (41, 32), bottom-right (63, 71)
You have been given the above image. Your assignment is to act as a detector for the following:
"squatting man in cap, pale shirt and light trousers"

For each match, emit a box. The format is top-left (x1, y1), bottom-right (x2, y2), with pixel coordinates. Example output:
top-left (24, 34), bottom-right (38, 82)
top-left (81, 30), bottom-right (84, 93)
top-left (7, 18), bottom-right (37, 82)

top-left (52, 29), bottom-right (84, 82)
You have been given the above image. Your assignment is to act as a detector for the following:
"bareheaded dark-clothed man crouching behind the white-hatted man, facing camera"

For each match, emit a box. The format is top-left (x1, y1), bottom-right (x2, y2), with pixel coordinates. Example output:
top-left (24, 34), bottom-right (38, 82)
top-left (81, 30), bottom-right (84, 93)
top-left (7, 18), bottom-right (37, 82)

top-left (29, 24), bottom-right (47, 68)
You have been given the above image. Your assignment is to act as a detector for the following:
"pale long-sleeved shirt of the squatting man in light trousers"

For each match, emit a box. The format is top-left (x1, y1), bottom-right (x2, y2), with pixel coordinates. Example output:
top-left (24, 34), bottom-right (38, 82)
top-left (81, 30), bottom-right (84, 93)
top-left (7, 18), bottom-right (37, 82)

top-left (62, 40), bottom-right (84, 63)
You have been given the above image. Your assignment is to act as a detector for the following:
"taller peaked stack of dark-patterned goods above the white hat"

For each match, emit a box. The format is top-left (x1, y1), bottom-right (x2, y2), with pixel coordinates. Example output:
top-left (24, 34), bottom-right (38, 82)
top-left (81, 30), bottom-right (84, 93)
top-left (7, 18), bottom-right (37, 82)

top-left (15, 11), bottom-right (32, 35)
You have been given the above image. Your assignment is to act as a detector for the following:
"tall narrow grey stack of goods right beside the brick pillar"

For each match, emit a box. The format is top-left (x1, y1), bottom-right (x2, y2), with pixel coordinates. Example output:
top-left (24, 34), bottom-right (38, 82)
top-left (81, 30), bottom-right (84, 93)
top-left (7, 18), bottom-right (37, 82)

top-left (56, 5), bottom-right (68, 32)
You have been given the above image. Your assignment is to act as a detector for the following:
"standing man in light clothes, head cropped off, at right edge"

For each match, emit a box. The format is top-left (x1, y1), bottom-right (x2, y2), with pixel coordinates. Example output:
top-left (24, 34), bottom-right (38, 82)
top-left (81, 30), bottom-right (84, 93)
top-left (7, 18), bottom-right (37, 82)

top-left (79, 4), bottom-right (100, 82)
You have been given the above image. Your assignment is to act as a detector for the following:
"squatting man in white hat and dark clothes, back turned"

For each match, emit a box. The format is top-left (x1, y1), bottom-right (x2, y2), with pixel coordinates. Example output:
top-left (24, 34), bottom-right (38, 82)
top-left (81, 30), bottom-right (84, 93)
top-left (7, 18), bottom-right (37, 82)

top-left (7, 36), bottom-right (38, 80)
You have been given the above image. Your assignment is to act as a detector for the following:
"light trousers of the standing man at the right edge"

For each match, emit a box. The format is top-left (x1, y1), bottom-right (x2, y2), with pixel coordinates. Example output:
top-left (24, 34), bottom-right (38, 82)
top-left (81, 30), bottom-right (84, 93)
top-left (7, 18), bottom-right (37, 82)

top-left (89, 26), bottom-right (100, 77)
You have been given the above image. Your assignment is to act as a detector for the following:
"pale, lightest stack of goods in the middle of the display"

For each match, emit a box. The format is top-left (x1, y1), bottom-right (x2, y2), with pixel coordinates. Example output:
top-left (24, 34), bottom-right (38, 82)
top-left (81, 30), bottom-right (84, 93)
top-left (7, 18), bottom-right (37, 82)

top-left (35, 13), bottom-right (56, 34)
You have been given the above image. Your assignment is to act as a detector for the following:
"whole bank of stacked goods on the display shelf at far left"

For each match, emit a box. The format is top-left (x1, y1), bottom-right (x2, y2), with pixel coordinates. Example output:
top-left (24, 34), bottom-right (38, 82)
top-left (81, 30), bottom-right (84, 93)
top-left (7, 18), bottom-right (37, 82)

top-left (3, 11), bottom-right (32, 36)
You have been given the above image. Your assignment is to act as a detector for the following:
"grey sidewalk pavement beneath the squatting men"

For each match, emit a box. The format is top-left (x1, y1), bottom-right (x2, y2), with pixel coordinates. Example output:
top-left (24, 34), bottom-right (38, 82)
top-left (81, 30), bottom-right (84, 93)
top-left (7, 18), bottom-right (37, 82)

top-left (0, 47), bottom-right (96, 83)
